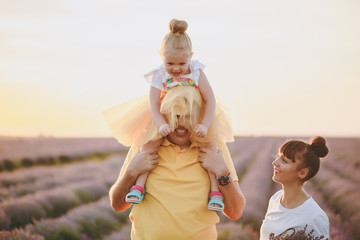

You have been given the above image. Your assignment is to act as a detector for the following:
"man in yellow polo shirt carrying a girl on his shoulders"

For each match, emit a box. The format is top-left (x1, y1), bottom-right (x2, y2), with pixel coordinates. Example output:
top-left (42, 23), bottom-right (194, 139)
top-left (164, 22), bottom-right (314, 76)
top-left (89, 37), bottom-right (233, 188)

top-left (110, 86), bottom-right (245, 240)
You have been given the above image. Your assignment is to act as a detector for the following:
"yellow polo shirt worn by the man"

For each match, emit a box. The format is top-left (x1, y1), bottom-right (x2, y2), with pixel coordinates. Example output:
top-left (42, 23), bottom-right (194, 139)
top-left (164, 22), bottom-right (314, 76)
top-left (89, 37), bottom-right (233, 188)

top-left (121, 139), bottom-right (237, 240)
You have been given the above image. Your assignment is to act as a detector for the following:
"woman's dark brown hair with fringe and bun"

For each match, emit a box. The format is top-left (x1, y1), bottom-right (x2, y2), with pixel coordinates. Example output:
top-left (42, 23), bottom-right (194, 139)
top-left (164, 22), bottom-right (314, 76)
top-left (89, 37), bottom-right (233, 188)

top-left (279, 137), bottom-right (329, 182)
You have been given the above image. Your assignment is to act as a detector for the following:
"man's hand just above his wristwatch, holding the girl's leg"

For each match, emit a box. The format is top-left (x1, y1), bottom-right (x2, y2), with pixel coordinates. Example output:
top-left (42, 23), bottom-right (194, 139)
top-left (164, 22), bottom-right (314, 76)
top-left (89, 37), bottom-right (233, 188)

top-left (198, 141), bottom-right (229, 177)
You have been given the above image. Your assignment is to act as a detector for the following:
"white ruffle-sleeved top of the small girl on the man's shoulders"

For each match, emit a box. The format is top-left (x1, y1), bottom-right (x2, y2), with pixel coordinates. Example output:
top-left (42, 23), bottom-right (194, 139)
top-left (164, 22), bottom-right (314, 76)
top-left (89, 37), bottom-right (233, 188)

top-left (145, 60), bottom-right (205, 90)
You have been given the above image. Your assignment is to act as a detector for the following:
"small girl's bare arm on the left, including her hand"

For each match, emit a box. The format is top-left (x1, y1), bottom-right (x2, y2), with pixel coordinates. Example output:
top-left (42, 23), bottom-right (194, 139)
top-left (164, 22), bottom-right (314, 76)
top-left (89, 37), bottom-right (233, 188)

top-left (150, 86), bottom-right (172, 136)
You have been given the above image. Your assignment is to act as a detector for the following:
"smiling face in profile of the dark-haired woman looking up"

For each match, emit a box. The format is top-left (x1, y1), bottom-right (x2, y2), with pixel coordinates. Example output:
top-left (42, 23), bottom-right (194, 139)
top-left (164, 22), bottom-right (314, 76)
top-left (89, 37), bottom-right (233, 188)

top-left (272, 153), bottom-right (302, 184)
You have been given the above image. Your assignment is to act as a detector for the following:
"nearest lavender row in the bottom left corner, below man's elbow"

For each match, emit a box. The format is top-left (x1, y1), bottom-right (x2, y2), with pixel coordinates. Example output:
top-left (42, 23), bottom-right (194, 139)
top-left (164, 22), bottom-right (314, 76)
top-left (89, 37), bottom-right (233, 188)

top-left (0, 196), bottom-right (127, 240)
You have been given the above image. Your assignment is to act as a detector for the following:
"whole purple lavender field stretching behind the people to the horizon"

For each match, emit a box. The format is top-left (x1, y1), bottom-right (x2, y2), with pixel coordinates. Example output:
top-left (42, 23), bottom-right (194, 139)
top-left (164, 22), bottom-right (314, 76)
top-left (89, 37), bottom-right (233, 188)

top-left (0, 137), bottom-right (360, 240)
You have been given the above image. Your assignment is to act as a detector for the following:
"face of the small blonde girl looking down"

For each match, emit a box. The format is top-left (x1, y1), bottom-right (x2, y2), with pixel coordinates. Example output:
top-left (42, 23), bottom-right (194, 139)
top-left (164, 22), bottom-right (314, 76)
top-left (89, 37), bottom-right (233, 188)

top-left (163, 47), bottom-right (192, 78)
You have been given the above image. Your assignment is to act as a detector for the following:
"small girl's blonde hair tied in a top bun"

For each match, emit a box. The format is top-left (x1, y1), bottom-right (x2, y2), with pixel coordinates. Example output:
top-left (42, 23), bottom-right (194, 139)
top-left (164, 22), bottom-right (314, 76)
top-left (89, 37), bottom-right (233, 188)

top-left (160, 19), bottom-right (192, 57)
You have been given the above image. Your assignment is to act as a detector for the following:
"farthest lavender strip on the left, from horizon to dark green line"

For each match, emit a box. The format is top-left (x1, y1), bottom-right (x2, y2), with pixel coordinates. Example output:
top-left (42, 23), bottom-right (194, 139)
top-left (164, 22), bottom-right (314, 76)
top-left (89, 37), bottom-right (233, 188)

top-left (0, 137), bottom-right (127, 171)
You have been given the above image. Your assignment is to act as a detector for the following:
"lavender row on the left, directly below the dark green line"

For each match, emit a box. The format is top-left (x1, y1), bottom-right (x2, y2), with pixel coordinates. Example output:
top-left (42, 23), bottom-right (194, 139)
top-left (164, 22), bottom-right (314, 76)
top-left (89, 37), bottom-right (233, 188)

top-left (0, 153), bottom-right (119, 202)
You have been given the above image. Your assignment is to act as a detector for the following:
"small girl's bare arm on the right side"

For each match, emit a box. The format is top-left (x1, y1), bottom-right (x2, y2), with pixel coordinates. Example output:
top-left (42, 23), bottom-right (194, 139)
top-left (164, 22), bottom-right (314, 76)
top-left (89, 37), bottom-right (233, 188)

top-left (199, 69), bottom-right (216, 128)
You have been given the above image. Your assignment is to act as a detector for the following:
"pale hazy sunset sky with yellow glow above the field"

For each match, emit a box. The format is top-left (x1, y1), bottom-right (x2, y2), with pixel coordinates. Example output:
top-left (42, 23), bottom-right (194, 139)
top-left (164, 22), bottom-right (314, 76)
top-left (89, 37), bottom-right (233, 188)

top-left (0, 0), bottom-right (360, 137)
